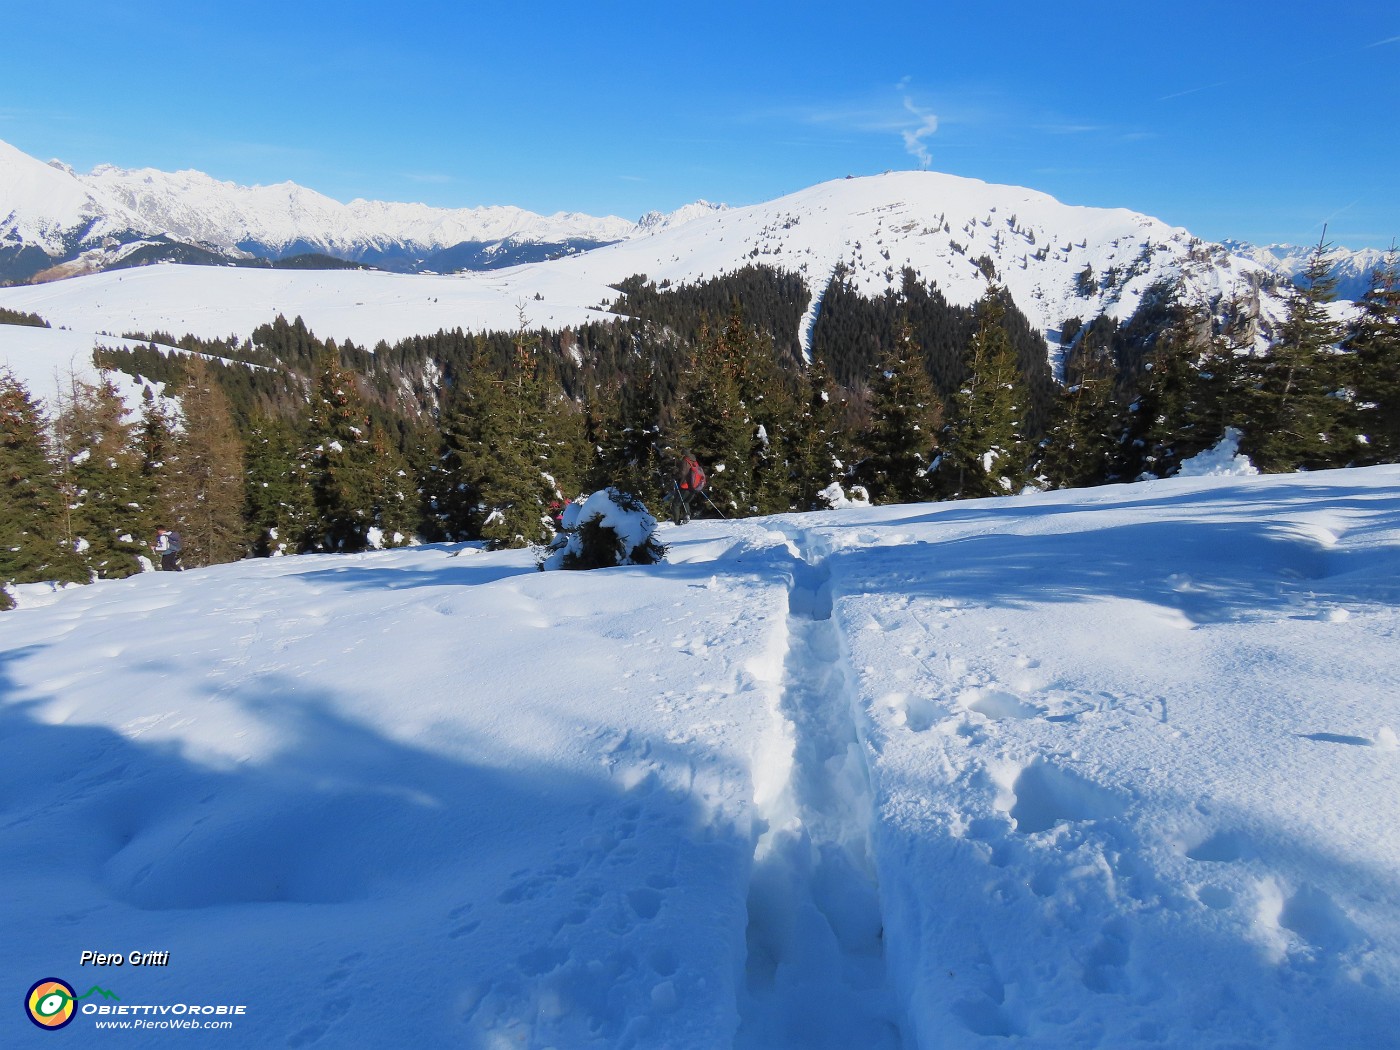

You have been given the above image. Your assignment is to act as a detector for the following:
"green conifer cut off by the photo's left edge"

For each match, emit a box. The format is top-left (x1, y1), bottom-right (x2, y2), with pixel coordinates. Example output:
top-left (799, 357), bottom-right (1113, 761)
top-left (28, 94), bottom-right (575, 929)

top-left (0, 370), bottom-right (88, 609)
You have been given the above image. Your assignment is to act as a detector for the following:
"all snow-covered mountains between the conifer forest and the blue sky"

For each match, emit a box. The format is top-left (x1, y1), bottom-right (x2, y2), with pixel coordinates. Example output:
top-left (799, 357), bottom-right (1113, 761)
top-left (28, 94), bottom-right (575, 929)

top-left (0, 135), bottom-right (1378, 366)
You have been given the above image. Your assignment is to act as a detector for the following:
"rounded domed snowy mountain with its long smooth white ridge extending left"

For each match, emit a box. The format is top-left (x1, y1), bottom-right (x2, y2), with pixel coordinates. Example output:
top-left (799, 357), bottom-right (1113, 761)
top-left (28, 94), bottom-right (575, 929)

top-left (0, 172), bottom-right (1273, 366)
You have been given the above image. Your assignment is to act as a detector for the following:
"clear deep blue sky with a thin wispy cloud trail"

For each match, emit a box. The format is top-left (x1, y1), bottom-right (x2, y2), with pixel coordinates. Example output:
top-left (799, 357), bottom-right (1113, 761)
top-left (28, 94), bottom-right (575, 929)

top-left (0, 0), bottom-right (1400, 248)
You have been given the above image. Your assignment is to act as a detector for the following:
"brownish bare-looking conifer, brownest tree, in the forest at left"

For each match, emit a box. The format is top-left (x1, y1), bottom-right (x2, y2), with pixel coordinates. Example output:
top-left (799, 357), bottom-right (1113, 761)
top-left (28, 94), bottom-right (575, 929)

top-left (160, 354), bottom-right (248, 566)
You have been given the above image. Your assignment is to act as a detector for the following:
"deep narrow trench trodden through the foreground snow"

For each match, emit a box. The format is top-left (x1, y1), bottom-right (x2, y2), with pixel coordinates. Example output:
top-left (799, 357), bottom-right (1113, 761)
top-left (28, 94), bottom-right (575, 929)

top-left (735, 532), bottom-right (904, 1050)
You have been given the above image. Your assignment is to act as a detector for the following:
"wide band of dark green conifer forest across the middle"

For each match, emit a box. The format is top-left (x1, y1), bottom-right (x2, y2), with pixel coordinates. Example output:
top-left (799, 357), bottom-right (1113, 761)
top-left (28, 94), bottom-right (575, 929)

top-left (0, 245), bottom-right (1400, 606)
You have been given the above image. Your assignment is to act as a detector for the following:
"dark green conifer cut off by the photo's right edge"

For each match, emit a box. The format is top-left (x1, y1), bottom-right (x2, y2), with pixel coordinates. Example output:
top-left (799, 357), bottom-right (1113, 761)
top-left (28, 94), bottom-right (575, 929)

top-left (1345, 248), bottom-right (1400, 463)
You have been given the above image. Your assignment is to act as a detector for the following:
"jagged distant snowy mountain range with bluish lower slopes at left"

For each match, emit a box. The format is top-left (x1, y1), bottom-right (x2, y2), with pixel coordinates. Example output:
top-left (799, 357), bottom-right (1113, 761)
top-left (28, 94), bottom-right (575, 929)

top-left (0, 141), bottom-right (733, 283)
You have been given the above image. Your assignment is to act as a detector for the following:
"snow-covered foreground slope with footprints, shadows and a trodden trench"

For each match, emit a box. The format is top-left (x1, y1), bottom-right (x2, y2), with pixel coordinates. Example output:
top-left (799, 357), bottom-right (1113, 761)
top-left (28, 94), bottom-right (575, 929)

top-left (0, 470), bottom-right (1400, 1050)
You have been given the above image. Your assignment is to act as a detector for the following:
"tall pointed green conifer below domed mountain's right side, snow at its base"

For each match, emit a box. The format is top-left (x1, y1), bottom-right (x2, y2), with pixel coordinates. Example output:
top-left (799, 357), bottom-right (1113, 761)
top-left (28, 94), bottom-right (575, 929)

top-left (937, 286), bottom-right (1030, 498)
